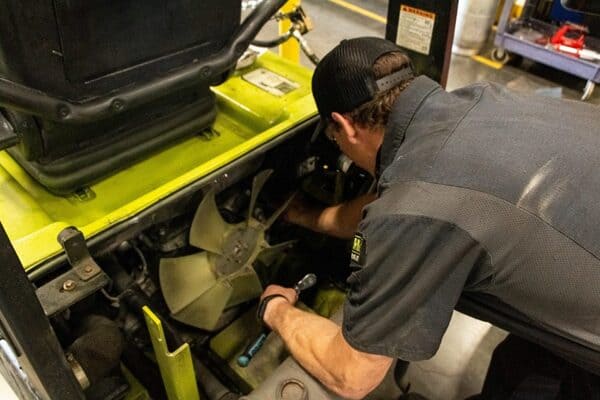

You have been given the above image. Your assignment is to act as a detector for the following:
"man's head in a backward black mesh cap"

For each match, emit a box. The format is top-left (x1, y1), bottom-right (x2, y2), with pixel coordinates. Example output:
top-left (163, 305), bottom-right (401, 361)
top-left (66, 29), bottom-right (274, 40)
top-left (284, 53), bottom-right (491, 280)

top-left (312, 37), bottom-right (414, 172)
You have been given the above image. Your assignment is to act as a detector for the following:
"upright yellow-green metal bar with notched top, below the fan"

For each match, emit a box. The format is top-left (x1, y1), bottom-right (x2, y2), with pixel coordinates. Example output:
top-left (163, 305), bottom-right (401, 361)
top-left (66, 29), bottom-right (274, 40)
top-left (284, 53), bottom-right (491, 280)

top-left (143, 306), bottom-right (200, 400)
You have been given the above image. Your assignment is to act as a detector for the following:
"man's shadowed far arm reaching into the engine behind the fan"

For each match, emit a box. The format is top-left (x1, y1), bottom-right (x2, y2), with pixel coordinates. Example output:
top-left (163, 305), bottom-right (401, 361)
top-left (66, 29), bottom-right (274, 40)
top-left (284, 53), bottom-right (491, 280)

top-left (285, 194), bottom-right (376, 239)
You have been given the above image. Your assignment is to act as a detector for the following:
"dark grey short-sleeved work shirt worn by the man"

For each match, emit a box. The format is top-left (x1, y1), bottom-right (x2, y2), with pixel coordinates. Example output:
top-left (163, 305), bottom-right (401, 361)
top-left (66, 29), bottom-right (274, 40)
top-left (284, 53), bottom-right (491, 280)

top-left (343, 77), bottom-right (600, 368)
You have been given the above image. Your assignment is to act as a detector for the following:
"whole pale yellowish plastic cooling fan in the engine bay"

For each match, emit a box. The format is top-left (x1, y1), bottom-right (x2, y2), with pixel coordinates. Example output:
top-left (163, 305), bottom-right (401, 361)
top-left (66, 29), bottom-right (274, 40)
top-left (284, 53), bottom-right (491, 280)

top-left (159, 170), bottom-right (294, 330)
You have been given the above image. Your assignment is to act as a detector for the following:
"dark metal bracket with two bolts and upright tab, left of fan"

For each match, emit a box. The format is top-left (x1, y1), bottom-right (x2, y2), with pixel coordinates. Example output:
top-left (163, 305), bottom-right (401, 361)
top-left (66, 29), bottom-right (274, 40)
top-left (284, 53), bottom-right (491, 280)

top-left (36, 227), bottom-right (110, 317)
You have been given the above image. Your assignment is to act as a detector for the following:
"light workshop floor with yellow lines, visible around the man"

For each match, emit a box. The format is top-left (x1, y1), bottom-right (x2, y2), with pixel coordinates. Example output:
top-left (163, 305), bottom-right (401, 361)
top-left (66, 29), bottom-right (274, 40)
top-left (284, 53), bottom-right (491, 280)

top-left (265, 0), bottom-right (600, 400)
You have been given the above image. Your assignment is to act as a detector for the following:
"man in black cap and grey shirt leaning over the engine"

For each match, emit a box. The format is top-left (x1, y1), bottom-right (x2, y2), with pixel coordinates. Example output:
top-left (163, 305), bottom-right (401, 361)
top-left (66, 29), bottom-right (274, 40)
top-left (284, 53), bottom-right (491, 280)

top-left (261, 38), bottom-right (600, 399)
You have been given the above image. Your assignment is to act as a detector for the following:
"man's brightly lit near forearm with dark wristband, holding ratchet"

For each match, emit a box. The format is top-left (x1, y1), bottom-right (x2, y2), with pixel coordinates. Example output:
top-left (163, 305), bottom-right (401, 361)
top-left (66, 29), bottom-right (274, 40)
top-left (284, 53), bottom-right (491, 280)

top-left (263, 285), bottom-right (393, 399)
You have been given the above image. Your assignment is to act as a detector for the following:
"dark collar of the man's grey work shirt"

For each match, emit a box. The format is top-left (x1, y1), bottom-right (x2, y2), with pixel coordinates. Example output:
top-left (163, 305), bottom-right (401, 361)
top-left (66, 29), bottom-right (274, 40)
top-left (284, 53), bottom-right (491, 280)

top-left (375, 75), bottom-right (440, 179)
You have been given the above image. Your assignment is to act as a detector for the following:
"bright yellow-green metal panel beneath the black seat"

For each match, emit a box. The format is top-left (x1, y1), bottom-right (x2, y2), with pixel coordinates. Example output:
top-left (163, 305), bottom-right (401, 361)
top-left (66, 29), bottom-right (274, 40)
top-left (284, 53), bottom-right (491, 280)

top-left (0, 52), bottom-right (316, 269)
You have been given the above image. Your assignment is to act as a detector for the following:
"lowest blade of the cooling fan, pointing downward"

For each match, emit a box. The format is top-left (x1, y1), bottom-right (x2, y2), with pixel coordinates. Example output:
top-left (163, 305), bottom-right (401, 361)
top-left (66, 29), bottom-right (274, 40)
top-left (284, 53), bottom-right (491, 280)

top-left (173, 281), bottom-right (233, 331)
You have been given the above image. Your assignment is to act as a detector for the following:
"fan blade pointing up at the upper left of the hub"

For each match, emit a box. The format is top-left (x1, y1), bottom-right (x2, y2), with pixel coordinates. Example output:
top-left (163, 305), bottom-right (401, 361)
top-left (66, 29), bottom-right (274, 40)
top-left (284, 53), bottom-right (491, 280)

top-left (190, 190), bottom-right (230, 254)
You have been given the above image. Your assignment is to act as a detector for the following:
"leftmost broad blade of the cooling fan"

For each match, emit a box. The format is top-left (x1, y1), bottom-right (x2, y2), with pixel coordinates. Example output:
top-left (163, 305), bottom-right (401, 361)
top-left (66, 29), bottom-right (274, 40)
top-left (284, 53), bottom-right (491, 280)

top-left (159, 252), bottom-right (217, 314)
